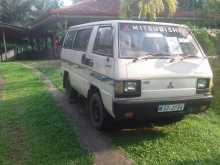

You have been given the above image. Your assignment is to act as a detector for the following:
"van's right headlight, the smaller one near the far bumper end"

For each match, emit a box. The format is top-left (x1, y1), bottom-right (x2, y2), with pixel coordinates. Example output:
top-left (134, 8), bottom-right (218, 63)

top-left (197, 78), bottom-right (211, 94)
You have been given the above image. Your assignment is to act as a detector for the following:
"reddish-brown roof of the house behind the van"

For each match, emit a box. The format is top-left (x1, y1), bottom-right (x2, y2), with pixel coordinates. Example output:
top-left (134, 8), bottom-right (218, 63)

top-left (30, 0), bottom-right (220, 31)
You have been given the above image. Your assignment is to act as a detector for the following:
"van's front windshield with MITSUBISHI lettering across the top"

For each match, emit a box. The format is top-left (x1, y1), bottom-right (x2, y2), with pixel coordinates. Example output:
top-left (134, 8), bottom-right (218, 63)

top-left (119, 23), bottom-right (203, 58)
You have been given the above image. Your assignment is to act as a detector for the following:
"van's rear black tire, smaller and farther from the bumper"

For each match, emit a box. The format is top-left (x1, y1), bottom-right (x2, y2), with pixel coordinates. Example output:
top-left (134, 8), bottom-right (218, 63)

top-left (63, 75), bottom-right (78, 100)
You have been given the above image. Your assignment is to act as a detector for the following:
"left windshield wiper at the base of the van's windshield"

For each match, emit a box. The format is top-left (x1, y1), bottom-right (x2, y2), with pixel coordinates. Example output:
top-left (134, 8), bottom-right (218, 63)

top-left (133, 53), bottom-right (173, 62)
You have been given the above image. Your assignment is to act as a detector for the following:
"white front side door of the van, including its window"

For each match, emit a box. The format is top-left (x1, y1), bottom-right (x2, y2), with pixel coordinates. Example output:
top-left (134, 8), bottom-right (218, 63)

top-left (89, 26), bottom-right (114, 114)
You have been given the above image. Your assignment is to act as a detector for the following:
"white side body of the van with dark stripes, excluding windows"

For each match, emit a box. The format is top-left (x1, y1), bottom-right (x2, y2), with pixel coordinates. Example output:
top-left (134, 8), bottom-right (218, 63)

top-left (61, 26), bottom-right (114, 117)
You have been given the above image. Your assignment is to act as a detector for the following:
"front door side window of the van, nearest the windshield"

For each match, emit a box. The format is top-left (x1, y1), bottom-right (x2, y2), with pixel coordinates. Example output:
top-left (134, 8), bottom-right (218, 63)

top-left (93, 26), bottom-right (113, 57)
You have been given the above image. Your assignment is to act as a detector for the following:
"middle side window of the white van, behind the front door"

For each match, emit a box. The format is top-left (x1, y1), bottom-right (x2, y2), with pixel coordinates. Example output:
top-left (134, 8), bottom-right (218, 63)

top-left (73, 29), bottom-right (92, 51)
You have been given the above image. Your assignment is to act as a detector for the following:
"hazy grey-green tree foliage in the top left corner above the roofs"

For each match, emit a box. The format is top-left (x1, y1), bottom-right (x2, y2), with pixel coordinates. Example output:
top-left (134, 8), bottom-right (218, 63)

top-left (0, 0), bottom-right (61, 25)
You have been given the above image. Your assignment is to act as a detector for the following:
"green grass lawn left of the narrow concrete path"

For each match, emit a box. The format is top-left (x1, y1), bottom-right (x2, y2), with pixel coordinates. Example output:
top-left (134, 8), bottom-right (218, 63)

top-left (0, 62), bottom-right (94, 165)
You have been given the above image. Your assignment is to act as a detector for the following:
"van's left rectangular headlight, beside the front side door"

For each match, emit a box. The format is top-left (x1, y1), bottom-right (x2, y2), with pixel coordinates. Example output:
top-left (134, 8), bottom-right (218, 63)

top-left (115, 81), bottom-right (141, 98)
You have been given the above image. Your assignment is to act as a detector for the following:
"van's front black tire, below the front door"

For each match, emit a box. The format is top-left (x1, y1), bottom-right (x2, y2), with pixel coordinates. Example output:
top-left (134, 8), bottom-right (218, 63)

top-left (89, 92), bottom-right (112, 131)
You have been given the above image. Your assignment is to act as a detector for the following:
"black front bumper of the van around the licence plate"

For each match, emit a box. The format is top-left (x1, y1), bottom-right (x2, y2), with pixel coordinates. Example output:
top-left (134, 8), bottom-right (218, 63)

top-left (113, 95), bottom-right (213, 121)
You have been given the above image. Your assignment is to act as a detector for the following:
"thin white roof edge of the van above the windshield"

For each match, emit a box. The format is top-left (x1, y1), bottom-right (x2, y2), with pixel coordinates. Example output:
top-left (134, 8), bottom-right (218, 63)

top-left (69, 20), bottom-right (187, 29)
